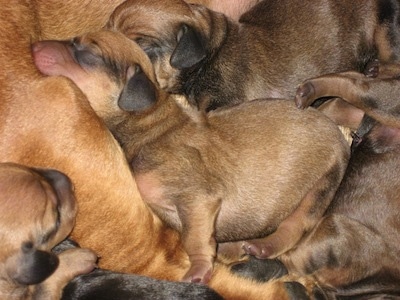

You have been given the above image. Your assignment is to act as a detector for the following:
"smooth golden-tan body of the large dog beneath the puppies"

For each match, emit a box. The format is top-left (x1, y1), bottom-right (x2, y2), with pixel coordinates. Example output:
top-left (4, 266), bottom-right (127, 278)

top-left (0, 1), bottom-right (318, 299)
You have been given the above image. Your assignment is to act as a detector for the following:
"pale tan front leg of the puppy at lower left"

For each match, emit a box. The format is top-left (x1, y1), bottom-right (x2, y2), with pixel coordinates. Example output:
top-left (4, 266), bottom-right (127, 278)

top-left (33, 248), bottom-right (97, 300)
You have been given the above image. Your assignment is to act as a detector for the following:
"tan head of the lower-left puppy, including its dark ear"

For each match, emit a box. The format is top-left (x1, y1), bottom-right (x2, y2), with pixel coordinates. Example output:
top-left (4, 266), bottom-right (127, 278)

top-left (0, 163), bottom-right (76, 285)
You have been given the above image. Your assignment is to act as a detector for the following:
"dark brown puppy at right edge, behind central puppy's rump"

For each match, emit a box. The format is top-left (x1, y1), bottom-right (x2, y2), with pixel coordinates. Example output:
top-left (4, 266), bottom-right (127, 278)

top-left (268, 64), bottom-right (400, 299)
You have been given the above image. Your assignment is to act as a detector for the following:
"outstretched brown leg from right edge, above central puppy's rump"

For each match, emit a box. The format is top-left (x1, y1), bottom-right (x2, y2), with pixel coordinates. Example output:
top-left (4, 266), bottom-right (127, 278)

top-left (295, 65), bottom-right (400, 127)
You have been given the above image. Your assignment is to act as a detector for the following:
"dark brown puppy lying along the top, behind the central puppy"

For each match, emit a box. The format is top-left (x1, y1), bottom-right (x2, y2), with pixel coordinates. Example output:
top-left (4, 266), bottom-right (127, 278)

top-left (108, 0), bottom-right (399, 110)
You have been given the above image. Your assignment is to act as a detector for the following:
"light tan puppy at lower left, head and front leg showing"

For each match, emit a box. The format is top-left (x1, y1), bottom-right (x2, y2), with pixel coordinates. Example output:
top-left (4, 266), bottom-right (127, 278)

top-left (0, 163), bottom-right (97, 300)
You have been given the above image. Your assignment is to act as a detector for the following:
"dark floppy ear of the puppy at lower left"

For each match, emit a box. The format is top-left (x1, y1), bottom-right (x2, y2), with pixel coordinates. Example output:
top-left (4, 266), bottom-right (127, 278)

top-left (10, 243), bottom-right (59, 285)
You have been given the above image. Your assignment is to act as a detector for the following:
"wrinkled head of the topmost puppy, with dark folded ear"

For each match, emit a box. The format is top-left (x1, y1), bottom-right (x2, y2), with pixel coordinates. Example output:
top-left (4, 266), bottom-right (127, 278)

top-left (107, 0), bottom-right (226, 93)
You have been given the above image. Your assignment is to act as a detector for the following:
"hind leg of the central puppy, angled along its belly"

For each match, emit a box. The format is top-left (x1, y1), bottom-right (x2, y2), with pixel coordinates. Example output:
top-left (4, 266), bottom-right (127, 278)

top-left (244, 164), bottom-right (346, 258)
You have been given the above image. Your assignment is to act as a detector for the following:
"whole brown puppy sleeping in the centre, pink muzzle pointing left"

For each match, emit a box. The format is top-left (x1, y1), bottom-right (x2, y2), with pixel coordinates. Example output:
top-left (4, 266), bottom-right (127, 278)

top-left (35, 31), bottom-right (349, 282)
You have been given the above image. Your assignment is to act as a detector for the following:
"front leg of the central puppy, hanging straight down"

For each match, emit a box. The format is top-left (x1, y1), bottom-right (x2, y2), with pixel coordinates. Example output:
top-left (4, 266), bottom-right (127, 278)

top-left (178, 195), bottom-right (221, 283)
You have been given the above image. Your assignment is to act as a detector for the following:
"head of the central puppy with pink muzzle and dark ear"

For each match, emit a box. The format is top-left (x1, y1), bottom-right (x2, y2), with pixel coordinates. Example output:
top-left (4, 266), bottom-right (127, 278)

top-left (33, 30), bottom-right (158, 125)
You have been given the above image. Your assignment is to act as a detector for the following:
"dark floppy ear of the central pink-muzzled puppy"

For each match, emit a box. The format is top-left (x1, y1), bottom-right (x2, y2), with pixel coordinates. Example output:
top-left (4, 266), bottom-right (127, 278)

top-left (118, 66), bottom-right (157, 112)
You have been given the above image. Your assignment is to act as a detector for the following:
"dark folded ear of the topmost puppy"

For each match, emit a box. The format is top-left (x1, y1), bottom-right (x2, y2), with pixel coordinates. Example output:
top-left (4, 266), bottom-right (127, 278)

top-left (170, 25), bottom-right (206, 69)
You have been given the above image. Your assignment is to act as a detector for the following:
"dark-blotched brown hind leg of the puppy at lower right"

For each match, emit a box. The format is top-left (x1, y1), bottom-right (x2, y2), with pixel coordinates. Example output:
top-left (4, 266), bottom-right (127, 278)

top-left (280, 214), bottom-right (396, 288)
